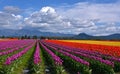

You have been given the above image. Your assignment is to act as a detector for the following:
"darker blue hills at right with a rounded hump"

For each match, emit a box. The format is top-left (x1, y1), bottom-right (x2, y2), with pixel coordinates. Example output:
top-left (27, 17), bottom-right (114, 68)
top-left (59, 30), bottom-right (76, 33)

top-left (72, 33), bottom-right (120, 40)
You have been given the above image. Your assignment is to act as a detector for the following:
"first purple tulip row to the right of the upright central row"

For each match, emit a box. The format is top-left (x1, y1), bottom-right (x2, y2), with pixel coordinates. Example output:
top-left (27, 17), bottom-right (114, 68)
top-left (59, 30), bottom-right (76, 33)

top-left (40, 42), bottom-right (63, 65)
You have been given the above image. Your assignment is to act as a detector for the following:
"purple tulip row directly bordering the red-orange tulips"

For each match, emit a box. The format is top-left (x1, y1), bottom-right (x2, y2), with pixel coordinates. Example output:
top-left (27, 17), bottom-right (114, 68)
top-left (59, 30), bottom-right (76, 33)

top-left (44, 42), bottom-right (120, 65)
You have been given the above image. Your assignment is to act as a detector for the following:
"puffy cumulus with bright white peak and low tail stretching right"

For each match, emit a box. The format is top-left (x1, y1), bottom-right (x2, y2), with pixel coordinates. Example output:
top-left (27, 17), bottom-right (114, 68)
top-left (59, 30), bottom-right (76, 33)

top-left (24, 7), bottom-right (98, 34)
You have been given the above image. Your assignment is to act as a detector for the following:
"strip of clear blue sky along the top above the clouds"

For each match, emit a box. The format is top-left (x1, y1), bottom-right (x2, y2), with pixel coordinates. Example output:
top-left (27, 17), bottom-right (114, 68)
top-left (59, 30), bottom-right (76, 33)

top-left (0, 0), bottom-right (118, 9)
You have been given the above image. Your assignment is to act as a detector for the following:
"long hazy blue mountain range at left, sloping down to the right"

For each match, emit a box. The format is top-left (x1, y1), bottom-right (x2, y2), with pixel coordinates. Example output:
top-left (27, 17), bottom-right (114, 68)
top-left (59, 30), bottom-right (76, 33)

top-left (0, 29), bottom-right (73, 37)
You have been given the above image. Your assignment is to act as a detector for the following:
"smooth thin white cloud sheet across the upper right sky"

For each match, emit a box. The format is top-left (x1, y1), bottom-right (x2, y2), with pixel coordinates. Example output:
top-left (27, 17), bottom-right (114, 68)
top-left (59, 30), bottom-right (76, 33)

top-left (57, 2), bottom-right (120, 22)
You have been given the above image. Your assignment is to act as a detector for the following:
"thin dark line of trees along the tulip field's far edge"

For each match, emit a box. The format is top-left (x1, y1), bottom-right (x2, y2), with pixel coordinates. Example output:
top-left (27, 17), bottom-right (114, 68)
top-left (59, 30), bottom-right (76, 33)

top-left (0, 35), bottom-right (120, 41)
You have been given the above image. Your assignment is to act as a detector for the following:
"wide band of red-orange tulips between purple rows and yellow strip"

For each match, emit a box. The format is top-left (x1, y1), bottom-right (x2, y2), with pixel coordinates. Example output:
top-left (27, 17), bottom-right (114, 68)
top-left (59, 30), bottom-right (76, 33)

top-left (47, 40), bottom-right (120, 57)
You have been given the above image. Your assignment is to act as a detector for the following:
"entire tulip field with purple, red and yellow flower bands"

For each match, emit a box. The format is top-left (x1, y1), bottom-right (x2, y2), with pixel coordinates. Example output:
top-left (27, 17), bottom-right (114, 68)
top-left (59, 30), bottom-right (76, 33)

top-left (0, 39), bottom-right (120, 74)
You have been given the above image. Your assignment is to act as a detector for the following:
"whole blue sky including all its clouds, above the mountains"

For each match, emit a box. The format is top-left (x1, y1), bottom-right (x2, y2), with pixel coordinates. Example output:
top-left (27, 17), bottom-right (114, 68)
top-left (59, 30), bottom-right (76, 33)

top-left (0, 0), bottom-right (120, 35)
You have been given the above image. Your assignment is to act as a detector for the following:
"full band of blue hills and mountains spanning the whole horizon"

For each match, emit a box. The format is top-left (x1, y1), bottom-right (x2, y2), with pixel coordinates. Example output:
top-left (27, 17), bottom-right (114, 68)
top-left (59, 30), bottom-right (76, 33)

top-left (0, 29), bottom-right (120, 40)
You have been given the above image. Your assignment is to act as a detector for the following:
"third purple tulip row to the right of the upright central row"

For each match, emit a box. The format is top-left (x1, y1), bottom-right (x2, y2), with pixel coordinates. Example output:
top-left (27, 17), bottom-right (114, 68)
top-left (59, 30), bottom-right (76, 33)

top-left (41, 42), bottom-right (114, 67)
